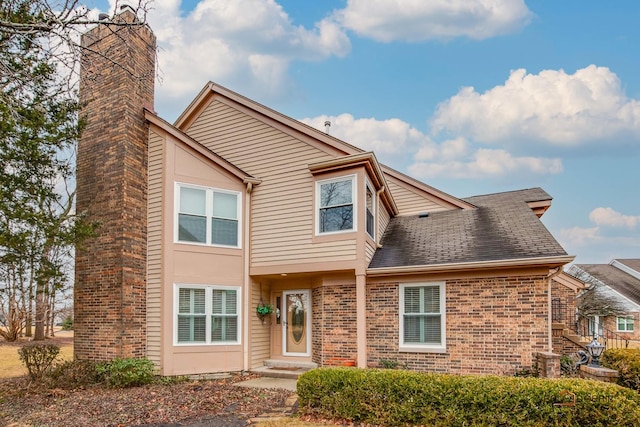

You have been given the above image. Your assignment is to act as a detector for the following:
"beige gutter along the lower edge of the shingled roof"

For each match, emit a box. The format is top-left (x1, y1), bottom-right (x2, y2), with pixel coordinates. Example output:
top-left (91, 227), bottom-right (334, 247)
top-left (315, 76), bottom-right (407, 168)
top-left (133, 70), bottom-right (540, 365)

top-left (367, 255), bottom-right (575, 277)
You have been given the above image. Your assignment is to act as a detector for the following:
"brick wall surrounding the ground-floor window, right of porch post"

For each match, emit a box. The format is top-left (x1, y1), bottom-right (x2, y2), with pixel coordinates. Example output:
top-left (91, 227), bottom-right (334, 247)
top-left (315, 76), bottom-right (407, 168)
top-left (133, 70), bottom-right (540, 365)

top-left (367, 275), bottom-right (549, 375)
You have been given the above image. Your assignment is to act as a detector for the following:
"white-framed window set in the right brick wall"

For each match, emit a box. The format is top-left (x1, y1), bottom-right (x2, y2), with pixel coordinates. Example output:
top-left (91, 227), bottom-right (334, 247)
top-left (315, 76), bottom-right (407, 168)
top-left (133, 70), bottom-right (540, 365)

top-left (399, 282), bottom-right (446, 352)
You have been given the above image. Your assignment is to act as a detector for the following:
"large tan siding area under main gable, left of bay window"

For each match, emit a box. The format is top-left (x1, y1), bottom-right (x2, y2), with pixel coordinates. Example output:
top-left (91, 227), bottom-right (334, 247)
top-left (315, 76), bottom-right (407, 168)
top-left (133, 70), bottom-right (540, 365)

top-left (187, 100), bottom-right (356, 267)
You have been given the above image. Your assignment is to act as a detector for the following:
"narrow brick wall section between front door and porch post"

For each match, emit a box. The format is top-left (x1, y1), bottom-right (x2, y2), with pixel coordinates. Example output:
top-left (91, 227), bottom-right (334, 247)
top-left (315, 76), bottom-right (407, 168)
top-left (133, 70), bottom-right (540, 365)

top-left (312, 284), bottom-right (358, 366)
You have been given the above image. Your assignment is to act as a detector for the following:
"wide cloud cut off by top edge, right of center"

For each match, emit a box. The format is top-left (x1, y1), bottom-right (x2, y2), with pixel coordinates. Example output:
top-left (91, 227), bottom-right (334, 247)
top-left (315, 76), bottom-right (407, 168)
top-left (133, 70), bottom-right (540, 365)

top-left (334, 0), bottom-right (531, 42)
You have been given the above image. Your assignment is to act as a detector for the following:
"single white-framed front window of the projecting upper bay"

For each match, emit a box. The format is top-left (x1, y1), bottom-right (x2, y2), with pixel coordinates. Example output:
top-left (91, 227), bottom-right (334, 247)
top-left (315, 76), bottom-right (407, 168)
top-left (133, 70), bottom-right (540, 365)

top-left (316, 175), bottom-right (356, 234)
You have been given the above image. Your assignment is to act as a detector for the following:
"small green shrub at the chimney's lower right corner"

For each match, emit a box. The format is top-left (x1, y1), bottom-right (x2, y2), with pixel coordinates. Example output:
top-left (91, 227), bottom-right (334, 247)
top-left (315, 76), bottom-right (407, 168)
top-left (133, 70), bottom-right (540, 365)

top-left (96, 358), bottom-right (154, 388)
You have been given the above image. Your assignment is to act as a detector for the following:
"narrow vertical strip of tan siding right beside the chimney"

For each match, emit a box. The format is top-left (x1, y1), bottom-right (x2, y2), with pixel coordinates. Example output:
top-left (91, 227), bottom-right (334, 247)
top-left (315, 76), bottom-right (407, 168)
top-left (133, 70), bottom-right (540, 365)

top-left (147, 131), bottom-right (164, 366)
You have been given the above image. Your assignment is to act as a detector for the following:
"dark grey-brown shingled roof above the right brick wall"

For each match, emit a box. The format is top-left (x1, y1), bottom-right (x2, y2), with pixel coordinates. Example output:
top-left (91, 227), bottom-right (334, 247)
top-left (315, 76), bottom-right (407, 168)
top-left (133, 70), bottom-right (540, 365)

top-left (369, 188), bottom-right (567, 269)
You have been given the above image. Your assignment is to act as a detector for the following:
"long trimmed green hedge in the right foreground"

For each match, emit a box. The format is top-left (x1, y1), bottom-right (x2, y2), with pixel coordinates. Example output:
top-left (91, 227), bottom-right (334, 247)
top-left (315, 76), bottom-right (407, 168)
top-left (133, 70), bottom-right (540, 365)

top-left (297, 368), bottom-right (640, 426)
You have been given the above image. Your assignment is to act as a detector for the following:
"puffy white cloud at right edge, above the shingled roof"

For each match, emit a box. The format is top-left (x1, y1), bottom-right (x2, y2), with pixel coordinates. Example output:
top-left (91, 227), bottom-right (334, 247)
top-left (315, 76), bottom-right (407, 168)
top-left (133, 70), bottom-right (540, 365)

top-left (431, 65), bottom-right (640, 148)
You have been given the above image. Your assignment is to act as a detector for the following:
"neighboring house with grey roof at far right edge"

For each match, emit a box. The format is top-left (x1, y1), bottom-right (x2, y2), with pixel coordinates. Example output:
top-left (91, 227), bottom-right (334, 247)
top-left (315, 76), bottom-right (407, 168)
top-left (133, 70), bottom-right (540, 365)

top-left (569, 259), bottom-right (640, 340)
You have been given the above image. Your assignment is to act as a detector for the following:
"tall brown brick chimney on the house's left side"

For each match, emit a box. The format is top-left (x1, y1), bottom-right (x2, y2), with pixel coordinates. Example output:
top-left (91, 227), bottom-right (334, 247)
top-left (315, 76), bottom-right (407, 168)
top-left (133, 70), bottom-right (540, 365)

top-left (74, 8), bottom-right (155, 360)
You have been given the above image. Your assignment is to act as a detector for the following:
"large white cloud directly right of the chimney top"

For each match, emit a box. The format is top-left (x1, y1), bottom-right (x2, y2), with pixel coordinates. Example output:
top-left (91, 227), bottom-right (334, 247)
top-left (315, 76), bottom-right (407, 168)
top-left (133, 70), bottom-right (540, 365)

top-left (148, 0), bottom-right (351, 112)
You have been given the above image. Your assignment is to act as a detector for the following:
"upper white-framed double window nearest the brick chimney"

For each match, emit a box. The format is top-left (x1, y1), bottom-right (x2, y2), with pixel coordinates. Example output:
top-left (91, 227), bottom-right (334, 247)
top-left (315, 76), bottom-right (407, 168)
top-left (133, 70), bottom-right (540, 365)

top-left (176, 184), bottom-right (241, 248)
